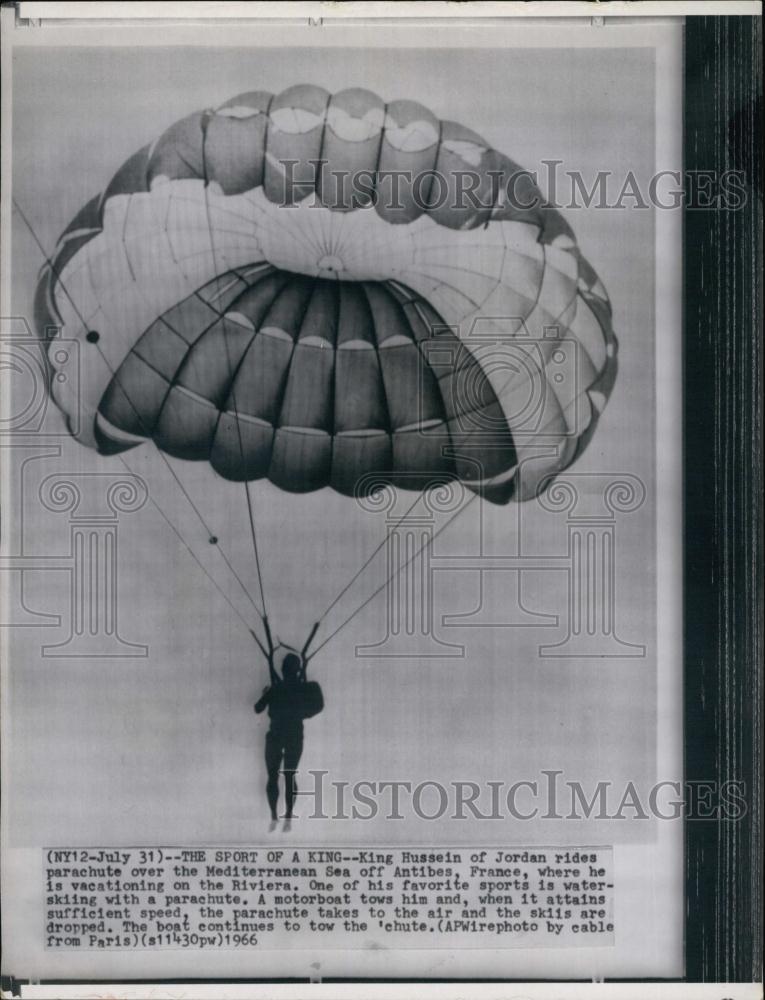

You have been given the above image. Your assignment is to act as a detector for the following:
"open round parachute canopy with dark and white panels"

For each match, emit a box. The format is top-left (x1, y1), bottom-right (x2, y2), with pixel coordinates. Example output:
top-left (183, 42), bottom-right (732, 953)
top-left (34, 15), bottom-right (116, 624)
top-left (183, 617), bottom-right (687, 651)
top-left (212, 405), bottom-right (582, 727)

top-left (36, 86), bottom-right (616, 503)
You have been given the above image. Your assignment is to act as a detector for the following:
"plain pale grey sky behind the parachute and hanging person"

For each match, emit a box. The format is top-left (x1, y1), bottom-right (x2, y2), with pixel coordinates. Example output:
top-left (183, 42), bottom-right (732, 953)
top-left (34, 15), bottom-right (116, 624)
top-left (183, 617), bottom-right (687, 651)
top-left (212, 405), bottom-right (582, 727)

top-left (5, 48), bottom-right (656, 846)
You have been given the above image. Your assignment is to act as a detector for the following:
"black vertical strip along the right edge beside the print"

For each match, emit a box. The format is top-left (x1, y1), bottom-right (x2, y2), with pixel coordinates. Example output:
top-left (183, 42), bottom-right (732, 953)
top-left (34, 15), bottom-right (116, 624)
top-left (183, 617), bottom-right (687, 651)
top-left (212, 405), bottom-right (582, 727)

top-left (684, 16), bottom-right (763, 983)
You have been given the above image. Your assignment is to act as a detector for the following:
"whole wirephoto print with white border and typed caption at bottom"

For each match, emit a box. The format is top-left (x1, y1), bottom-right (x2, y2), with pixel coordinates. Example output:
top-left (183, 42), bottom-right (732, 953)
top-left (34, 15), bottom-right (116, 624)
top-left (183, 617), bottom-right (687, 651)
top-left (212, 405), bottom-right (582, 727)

top-left (0, 4), bottom-right (756, 996)
